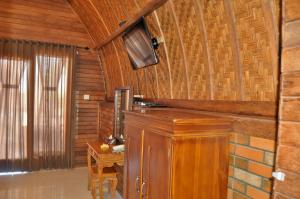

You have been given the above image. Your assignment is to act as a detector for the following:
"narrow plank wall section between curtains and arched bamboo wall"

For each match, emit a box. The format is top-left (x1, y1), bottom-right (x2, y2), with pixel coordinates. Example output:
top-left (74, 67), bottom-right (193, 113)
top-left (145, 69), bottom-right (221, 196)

top-left (72, 49), bottom-right (105, 166)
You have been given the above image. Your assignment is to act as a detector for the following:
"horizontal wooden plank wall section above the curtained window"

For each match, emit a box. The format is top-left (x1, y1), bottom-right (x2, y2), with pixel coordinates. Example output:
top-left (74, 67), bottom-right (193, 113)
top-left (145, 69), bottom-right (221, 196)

top-left (0, 0), bottom-right (92, 47)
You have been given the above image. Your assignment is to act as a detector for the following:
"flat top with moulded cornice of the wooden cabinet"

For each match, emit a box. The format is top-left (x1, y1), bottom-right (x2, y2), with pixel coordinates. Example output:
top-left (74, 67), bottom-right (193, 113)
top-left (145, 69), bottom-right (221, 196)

top-left (125, 108), bottom-right (232, 134)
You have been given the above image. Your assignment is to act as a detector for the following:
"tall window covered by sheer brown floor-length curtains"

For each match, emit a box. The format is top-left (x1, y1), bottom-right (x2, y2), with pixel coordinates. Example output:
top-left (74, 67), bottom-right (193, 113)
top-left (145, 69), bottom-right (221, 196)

top-left (0, 40), bottom-right (75, 172)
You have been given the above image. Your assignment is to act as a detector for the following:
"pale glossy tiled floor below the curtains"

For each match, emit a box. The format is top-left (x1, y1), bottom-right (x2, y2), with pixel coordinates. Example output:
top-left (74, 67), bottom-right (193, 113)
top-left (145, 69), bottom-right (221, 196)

top-left (0, 168), bottom-right (122, 199)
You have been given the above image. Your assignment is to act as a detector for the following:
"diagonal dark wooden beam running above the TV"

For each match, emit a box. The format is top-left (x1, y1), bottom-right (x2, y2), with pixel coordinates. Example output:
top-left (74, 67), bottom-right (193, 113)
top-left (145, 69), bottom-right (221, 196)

top-left (94, 0), bottom-right (168, 50)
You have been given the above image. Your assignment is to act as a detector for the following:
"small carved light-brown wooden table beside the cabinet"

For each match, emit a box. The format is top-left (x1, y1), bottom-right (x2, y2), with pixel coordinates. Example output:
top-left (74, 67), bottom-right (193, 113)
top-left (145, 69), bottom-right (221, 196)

top-left (87, 141), bottom-right (124, 198)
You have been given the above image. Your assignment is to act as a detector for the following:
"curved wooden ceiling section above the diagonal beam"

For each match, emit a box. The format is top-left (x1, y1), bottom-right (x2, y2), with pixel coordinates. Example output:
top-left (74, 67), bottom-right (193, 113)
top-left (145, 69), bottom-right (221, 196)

top-left (68, 0), bottom-right (146, 45)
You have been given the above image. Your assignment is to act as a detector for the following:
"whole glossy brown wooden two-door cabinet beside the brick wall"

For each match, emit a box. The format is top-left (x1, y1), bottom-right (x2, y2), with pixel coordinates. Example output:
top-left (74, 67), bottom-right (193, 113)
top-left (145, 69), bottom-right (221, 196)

top-left (124, 108), bottom-right (231, 199)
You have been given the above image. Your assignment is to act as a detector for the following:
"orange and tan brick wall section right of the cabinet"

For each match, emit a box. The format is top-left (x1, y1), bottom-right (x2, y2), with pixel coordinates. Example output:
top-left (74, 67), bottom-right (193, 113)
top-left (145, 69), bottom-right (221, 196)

top-left (228, 133), bottom-right (275, 199)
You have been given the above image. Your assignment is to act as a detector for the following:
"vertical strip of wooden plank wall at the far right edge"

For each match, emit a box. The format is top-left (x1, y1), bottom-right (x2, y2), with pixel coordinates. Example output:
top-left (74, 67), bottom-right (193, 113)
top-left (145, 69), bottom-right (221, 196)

top-left (274, 0), bottom-right (300, 199)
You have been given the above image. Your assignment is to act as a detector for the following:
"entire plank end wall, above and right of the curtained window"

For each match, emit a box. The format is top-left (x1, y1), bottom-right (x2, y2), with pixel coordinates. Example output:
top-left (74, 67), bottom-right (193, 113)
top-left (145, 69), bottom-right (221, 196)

top-left (0, 0), bottom-right (105, 166)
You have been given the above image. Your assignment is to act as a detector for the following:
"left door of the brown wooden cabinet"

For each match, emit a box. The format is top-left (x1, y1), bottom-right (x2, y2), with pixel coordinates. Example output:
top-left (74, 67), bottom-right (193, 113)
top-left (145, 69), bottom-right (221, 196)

top-left (124, 125), bottom-right (144, 199)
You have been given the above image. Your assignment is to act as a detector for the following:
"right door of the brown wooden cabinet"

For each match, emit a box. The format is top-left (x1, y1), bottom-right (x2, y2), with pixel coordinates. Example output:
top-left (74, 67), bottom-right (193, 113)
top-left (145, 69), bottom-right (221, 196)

top-left (141, 131), bottom-right (172, 199)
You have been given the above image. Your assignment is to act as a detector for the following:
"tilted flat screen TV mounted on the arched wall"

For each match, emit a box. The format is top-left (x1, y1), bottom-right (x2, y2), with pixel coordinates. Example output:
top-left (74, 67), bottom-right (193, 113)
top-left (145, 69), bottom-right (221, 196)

top-left (123, 18), bottom-right (158, 69)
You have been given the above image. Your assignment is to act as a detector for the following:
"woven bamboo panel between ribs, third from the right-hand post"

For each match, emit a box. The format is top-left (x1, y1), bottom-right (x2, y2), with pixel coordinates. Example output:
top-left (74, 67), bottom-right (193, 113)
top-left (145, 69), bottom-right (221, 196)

top-left (173, 0), bottom-right (210, 100)
